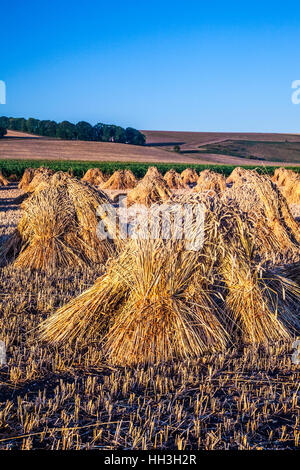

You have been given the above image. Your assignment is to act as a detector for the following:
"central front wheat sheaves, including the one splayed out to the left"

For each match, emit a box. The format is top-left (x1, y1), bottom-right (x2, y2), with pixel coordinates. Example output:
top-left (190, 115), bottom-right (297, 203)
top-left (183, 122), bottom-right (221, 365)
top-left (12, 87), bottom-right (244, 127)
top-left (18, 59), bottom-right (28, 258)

top-left (41, 240), bottom-right (228, 365)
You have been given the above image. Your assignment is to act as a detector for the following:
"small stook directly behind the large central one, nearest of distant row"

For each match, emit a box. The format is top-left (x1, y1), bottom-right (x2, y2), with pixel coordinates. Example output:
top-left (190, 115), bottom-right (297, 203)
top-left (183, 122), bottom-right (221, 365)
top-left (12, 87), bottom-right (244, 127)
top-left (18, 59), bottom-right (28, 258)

top-left (127, 175), bottom-right (172, 207)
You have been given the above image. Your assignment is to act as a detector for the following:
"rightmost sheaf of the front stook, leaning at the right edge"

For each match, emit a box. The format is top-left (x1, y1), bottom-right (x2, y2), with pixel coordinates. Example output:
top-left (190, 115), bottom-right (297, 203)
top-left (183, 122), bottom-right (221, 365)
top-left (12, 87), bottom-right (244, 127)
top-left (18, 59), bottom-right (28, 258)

top-left (220, 220), bottom-right (300, 346)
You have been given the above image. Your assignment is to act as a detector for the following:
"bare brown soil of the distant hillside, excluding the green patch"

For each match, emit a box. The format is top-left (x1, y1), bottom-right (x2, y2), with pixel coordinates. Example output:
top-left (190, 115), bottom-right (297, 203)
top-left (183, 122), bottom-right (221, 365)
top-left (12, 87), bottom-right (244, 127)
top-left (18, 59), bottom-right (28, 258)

top-left (0, 131), bottom-right (300, 166)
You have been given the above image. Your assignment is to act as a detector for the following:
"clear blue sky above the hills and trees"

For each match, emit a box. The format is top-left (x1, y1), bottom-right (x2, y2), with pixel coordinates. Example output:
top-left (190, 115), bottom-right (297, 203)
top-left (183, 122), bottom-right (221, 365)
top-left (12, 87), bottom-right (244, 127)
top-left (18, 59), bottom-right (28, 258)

top-left (0, 0), bottom-right (300, 132)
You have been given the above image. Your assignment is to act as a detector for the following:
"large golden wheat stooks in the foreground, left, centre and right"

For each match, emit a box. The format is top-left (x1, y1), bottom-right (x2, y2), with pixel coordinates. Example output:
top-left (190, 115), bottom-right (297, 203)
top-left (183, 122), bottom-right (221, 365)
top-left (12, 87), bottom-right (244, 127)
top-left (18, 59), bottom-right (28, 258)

top-left (0, 169), bottom-right (300, 365)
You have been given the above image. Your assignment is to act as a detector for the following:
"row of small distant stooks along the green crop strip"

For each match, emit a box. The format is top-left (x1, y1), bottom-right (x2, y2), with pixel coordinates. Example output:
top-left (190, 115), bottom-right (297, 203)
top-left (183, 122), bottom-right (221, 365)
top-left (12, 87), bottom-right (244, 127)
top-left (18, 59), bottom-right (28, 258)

top-left (5, 163), bottom-right (300, 205)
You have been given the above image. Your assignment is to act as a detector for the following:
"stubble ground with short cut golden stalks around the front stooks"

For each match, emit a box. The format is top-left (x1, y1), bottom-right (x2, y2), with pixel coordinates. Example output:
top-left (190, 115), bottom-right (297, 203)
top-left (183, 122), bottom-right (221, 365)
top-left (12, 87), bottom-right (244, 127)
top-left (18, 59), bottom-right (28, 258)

top-left (0, 183), bottom-right (300, 450)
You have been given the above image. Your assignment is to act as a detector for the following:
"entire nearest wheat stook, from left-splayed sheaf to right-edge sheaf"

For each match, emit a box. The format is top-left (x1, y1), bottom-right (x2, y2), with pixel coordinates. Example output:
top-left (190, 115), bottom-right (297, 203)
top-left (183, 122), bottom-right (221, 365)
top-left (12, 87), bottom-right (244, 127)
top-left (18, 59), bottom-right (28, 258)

top-left (42, 185), bottom-right (300, 365)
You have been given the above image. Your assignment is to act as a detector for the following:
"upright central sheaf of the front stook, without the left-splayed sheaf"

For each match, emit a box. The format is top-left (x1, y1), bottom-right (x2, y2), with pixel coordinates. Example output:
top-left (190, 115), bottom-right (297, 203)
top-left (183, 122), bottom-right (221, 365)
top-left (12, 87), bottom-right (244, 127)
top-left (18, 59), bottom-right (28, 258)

top-left (104, 241), bottom-right (228, 365)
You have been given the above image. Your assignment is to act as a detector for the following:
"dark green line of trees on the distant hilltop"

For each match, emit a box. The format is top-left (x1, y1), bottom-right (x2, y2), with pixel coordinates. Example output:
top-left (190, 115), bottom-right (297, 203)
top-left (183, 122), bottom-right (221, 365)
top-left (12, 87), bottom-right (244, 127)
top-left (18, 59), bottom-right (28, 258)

top-left (0, 116), bottom-right (146, 145)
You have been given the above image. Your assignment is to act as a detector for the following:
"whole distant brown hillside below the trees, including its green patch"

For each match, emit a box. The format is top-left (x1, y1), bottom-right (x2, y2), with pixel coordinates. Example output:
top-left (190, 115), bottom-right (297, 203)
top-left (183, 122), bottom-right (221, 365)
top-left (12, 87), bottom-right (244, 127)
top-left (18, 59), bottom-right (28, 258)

top-left (0, 131), bottom-right (300, 166)
